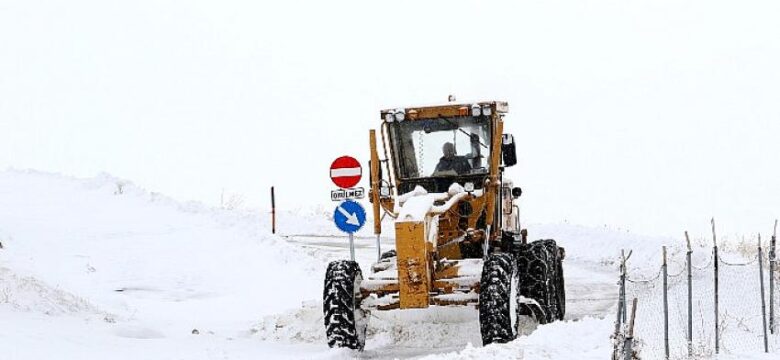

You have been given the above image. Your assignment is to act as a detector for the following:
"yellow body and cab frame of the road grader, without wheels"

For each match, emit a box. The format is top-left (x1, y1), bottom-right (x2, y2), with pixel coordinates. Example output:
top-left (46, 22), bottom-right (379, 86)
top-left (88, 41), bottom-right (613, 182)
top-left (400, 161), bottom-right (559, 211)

top-left (361, 101), bottom-right (519, 310)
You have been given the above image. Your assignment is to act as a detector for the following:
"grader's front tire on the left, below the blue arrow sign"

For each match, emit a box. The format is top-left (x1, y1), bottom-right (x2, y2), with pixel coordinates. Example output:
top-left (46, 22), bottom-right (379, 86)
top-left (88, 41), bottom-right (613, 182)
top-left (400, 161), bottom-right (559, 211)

top-left (322, 260), bottom-right (368, 350)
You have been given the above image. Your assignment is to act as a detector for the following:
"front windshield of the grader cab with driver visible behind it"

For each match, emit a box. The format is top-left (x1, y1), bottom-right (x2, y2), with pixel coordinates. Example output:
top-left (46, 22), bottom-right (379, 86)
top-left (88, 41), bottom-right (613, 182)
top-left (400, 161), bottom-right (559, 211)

top-left (390, 116), bottom-right (490, 179)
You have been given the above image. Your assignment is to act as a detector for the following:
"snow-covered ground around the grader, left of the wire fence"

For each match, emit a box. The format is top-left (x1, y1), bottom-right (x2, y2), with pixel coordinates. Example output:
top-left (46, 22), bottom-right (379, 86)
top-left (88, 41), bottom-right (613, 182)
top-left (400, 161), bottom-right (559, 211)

top-left (0, 171), bottom-right (769, 359)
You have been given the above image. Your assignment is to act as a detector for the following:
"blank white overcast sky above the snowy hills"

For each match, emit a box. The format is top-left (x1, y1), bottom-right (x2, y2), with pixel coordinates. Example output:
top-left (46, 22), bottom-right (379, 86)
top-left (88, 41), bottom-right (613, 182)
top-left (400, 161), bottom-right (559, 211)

top-left (0, 0), bottom-right (780, 239)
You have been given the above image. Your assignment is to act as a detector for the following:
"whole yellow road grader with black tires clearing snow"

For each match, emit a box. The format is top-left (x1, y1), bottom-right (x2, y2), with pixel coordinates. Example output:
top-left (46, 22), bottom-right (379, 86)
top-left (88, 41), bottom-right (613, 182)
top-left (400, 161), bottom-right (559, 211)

top-left (323, 101), bottom-right (566, 350)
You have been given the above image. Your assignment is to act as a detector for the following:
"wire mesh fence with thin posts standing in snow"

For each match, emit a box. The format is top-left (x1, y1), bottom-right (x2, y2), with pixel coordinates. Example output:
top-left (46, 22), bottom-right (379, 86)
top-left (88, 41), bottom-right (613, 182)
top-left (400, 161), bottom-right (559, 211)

top-left (616, 221), bottom-right (780, 359)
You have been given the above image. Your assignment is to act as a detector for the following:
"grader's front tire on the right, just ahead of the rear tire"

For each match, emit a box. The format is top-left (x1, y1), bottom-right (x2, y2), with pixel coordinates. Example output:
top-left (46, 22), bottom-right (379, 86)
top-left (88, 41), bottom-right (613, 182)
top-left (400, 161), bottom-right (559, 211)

top-left (479, 253), bottom-right (518, 345)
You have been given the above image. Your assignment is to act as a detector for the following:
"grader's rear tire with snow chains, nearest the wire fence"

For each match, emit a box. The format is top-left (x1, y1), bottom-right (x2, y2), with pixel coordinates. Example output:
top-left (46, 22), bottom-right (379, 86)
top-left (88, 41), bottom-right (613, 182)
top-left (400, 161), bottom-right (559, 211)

top-left (517, 240), bottom-right (566, 324)
